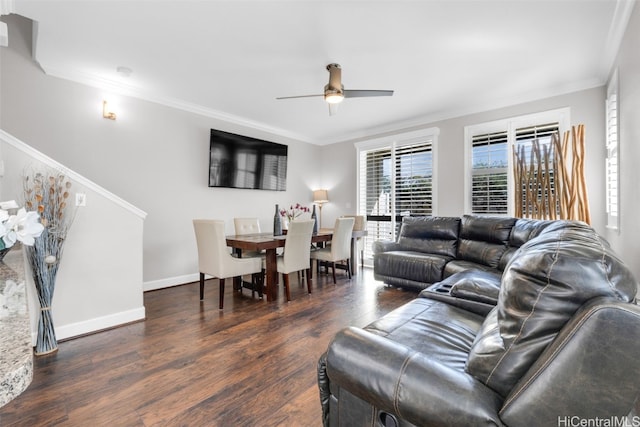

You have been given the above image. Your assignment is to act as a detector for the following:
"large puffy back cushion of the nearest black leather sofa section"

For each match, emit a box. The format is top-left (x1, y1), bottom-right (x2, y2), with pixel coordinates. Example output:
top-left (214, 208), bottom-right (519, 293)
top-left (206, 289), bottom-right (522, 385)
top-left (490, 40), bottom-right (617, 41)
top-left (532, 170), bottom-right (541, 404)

top-left (466, 221), bottom-right (637, 397)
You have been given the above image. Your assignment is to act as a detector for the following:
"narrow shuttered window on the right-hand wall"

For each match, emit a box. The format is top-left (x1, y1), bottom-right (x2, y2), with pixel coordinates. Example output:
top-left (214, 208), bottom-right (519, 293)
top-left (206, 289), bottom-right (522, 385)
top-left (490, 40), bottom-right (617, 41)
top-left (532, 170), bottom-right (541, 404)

top-left (605, 72), bottom-right (620, 230)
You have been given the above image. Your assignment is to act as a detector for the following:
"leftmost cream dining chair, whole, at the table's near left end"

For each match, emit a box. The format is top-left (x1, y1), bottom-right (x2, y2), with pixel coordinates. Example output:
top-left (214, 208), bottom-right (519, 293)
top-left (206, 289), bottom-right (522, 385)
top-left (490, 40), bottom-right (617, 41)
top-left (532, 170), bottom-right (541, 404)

top-left (193, 219), bottom-right (262, 309)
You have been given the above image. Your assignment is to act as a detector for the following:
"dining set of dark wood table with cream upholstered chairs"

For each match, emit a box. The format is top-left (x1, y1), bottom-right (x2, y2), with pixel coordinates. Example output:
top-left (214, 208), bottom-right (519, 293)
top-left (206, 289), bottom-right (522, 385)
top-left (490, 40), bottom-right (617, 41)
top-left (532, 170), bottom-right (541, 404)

top-left (193, 211), bottom-right (367, 310)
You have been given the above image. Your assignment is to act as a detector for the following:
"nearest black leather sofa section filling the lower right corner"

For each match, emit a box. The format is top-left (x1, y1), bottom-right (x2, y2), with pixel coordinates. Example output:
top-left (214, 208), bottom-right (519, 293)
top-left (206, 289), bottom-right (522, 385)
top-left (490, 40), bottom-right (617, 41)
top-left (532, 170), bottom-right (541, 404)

top-left (318, 220), bottom-right (640, 427)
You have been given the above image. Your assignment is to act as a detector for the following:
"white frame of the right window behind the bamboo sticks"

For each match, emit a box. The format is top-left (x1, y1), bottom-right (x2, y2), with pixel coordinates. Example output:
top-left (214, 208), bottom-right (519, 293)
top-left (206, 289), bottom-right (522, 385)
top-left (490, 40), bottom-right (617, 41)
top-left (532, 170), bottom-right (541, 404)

top-left (464, 107), bottom-right (571, 216)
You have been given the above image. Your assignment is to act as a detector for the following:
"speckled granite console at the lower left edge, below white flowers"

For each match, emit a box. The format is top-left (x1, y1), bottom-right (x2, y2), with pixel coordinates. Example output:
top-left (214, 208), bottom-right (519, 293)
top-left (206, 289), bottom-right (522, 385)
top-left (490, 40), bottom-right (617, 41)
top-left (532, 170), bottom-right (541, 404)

top-left (0, 246), bottom-right (33, 407)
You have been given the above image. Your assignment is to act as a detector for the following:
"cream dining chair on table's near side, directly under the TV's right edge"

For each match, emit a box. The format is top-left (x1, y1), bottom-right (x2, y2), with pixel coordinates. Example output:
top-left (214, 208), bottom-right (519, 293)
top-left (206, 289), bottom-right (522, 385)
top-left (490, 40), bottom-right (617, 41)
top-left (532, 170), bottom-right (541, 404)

top-left (276, 220), bottom-right (315, 301)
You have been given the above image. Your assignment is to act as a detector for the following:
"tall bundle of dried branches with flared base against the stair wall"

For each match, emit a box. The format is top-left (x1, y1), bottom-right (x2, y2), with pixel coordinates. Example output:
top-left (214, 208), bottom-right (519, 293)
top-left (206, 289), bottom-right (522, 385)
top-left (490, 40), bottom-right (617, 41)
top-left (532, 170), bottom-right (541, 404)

top-left (23, 171), bottom-right (75, 355)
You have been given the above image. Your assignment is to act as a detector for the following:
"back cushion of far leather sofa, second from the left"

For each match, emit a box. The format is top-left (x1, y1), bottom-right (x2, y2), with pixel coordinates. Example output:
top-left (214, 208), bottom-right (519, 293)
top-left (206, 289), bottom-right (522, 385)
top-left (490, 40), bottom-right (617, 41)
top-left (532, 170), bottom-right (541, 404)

top-left (457, 215), bottom-right (516, 268)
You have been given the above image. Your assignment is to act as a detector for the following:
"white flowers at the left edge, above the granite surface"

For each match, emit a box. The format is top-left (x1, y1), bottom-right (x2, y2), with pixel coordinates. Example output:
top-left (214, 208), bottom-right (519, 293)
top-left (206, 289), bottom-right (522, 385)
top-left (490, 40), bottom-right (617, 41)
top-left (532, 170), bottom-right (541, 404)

top-left (0, 200), bottom-right (44, 254)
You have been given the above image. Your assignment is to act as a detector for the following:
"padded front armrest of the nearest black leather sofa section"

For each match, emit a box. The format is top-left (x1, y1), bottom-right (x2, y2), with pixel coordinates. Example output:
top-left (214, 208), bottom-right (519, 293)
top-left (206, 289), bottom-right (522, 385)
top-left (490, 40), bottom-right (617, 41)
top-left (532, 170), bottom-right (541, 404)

top-left (326, 327), bottom-right (502, 425)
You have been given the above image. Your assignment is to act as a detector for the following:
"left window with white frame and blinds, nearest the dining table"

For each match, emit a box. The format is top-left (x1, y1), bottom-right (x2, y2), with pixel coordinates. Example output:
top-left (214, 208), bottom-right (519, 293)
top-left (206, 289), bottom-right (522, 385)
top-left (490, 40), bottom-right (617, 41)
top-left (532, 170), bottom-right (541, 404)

top-left (356, 129), bottom-right (437, 264)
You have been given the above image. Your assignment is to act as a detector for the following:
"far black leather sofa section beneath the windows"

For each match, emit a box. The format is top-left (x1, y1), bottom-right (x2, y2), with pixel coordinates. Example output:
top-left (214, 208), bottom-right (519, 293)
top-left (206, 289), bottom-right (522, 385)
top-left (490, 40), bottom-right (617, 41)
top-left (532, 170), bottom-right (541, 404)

top-left (373, 215), bottom-right (550, 290)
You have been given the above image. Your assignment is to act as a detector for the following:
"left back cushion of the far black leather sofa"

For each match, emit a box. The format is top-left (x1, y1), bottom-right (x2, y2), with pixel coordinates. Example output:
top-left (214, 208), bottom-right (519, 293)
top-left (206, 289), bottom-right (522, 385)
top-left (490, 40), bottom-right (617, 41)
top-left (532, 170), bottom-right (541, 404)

top-left (398, 216), bottom-right (460, 258)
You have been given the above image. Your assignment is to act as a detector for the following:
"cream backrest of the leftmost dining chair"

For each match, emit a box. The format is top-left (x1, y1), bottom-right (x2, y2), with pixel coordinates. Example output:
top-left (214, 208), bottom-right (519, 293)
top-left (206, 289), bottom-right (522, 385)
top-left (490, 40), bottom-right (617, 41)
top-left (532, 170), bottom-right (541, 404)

top-left (193, 219), bottom-right (232, 278)
